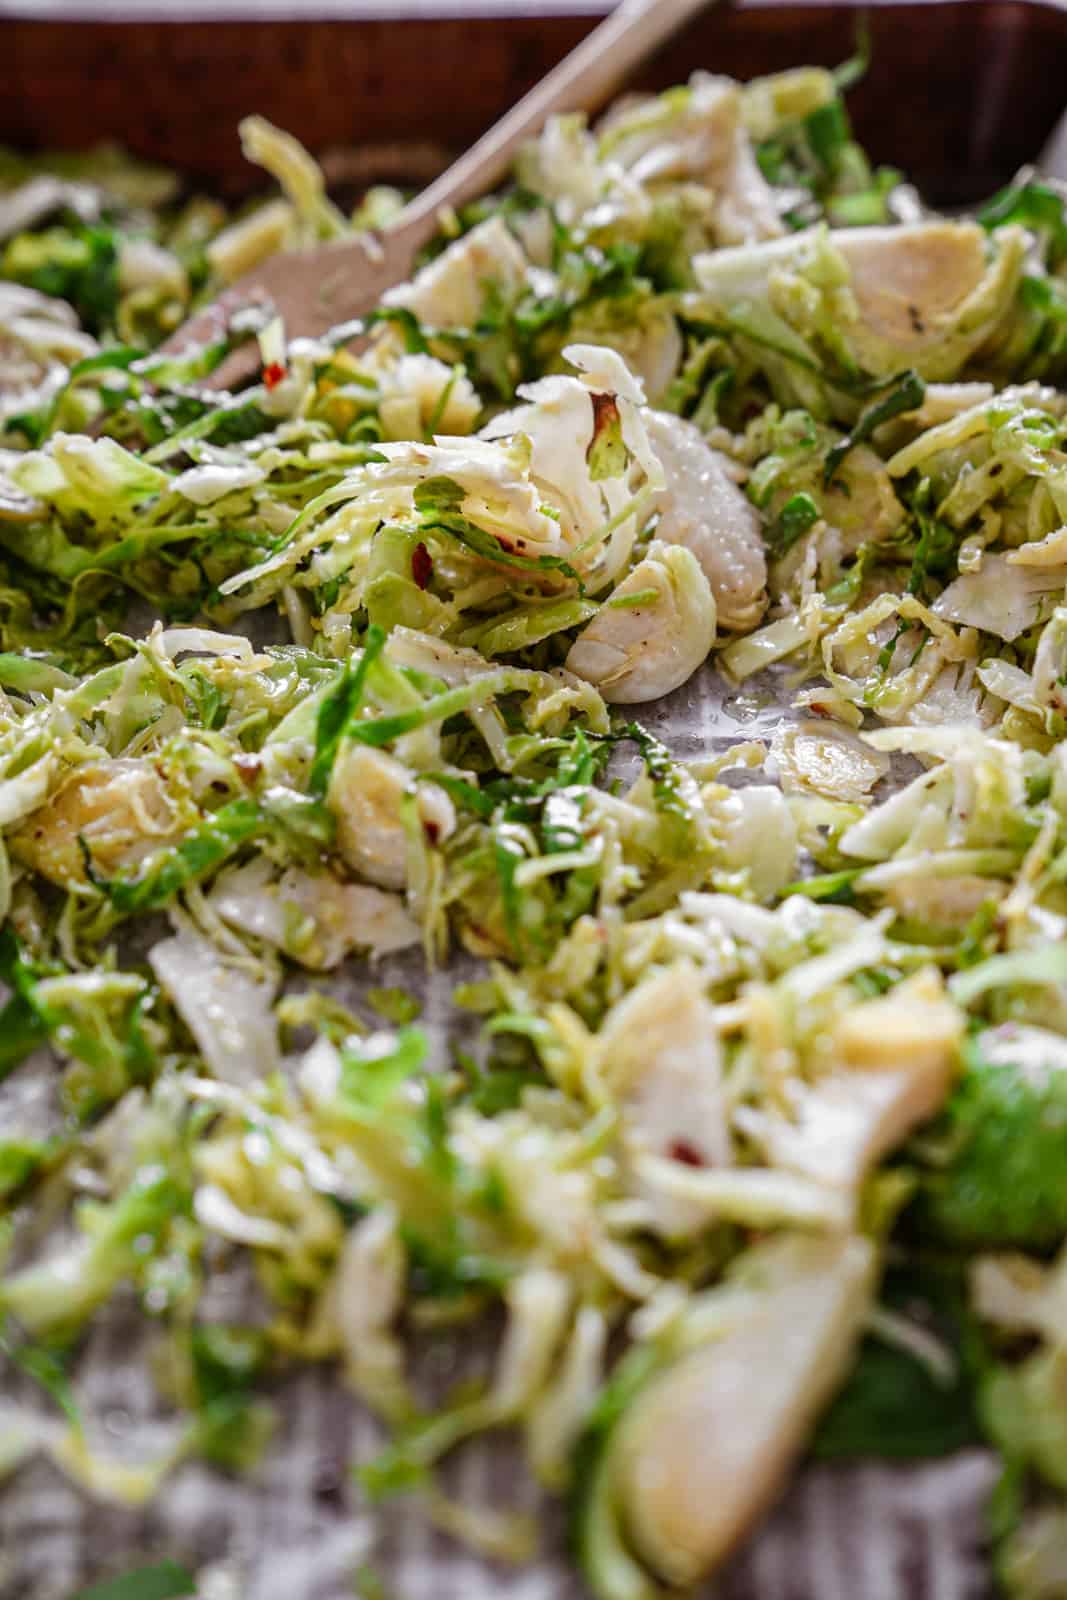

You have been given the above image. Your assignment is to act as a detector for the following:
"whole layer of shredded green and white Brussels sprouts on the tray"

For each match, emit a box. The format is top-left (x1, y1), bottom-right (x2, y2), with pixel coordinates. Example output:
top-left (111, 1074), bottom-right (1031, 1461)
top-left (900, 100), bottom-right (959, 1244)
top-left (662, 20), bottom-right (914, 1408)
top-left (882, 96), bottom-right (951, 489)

top-left (0, 46), bottom-right (1067, 1600)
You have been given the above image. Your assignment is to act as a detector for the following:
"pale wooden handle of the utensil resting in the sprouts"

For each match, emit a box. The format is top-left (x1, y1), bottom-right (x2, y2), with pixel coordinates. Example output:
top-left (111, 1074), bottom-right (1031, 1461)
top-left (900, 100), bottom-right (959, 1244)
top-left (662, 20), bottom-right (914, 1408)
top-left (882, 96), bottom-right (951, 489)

top-left (395, 0), bottom-right (709, 243)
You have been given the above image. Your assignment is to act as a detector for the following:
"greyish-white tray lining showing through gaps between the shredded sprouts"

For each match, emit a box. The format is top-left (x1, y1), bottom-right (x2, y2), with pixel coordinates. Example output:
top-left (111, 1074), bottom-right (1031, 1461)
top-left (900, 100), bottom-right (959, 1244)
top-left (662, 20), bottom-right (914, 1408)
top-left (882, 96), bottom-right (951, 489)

top-left (0, 667), bottom-right (995, 1600)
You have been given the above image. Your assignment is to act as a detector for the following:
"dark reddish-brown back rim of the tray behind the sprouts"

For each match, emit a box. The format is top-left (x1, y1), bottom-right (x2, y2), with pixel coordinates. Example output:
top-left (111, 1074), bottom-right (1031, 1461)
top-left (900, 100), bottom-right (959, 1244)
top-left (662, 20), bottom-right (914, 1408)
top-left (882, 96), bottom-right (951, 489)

top-left (0, 0), bottom-right (1067, 202)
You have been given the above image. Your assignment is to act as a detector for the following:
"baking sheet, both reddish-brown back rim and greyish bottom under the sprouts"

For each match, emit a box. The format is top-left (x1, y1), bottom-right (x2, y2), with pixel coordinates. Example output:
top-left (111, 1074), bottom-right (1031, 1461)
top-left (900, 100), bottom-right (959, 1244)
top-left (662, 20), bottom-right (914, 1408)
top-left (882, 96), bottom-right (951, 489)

top-left (0, 0), bottom-right (1067, 1600)
